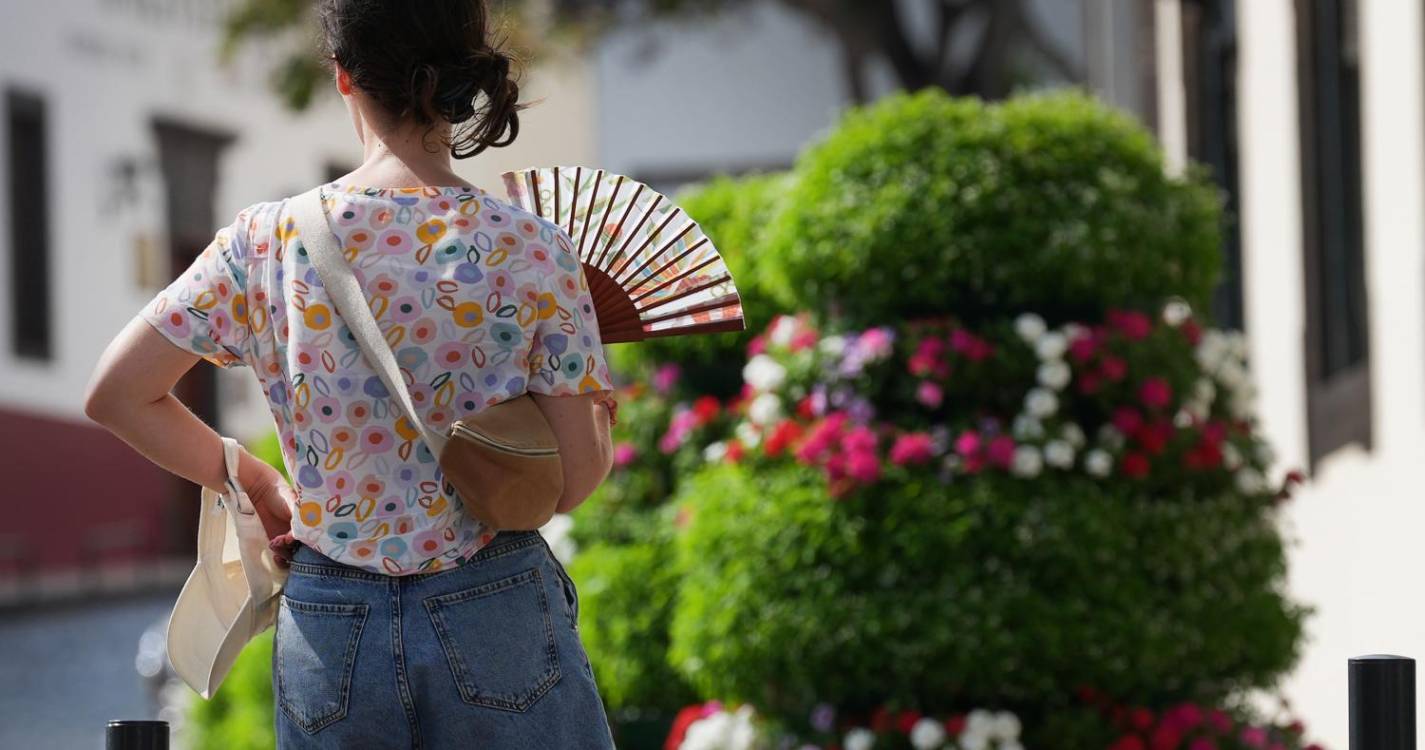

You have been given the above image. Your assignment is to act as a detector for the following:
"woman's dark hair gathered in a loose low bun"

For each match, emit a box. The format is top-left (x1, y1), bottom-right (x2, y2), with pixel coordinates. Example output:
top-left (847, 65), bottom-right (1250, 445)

top-left (319, 0), bottom-right (524, 158)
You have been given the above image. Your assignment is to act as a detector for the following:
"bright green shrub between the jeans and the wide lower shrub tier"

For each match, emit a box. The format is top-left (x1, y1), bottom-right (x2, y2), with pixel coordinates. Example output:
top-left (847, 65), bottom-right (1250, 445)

top-left (569, 533), bottom-right (695, 712)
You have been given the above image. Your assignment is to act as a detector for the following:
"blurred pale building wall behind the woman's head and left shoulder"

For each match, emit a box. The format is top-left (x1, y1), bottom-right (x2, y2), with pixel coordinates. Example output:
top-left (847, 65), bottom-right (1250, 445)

top-left (0, 0), bottom-right (594, 438)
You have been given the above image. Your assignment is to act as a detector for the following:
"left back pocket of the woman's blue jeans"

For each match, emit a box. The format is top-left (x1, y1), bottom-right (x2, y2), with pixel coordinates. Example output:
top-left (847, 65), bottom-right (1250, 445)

top-left (272, 593), bottom-right (371, 734)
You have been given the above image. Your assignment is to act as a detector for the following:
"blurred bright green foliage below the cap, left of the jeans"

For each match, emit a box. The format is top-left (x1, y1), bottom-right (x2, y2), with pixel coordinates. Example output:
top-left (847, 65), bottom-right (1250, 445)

top-left (188, 629), bottom-right (276, 750)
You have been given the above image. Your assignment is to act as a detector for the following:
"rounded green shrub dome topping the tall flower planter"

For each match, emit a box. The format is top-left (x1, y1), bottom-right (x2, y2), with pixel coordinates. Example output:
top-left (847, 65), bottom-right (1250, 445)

top-left (761, 90), bottom-right (1221, 324)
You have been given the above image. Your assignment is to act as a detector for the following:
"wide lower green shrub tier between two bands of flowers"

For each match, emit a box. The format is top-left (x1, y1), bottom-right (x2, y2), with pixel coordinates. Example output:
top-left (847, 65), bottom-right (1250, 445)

top-left (670, 465), bottom-right (1302, 717)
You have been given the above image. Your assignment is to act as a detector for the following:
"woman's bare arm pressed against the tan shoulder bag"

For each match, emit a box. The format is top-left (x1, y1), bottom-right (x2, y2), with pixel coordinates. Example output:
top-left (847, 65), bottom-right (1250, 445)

top-left (530, 391), bottom-right (613, 513)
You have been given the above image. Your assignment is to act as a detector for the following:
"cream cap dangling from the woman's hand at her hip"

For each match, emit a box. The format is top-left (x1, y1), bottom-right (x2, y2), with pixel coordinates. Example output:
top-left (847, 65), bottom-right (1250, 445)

top-left (168, 438), bottom-right (286, 699)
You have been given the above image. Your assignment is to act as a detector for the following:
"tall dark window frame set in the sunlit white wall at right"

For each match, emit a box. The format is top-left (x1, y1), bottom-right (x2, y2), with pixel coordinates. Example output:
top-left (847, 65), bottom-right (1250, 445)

top-left (1295, 0), bottom-right (1374, 469)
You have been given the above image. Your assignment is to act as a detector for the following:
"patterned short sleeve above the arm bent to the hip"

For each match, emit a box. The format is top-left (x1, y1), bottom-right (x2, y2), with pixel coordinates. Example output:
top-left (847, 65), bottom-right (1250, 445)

top-left (140, 210), bottom-right (251, 368)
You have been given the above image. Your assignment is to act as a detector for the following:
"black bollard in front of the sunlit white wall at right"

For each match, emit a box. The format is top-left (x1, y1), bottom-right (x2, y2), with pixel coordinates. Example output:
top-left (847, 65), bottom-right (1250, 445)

top-left (1351, 654), bottom-right (1415, 750)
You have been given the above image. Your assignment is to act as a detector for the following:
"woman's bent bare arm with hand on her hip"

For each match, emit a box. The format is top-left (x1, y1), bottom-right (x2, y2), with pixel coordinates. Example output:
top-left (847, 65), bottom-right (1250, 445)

top-left (84, 317), bottom-right (291, 538)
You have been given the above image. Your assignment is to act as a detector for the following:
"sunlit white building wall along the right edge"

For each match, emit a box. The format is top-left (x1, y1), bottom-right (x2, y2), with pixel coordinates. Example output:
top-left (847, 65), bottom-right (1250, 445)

top-left (1237, 0), bottom-right (1425, 747)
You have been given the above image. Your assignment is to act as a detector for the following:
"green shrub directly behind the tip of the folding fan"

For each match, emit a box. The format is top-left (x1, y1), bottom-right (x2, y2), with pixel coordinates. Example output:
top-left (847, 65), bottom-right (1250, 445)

top-left (608, 173), bottom-right (791, 396)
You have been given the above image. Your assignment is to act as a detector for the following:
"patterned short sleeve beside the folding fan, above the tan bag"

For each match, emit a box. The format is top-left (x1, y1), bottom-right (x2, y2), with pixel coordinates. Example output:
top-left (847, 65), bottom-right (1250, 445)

top-left (529, 230), bottom-right (613, 396)
